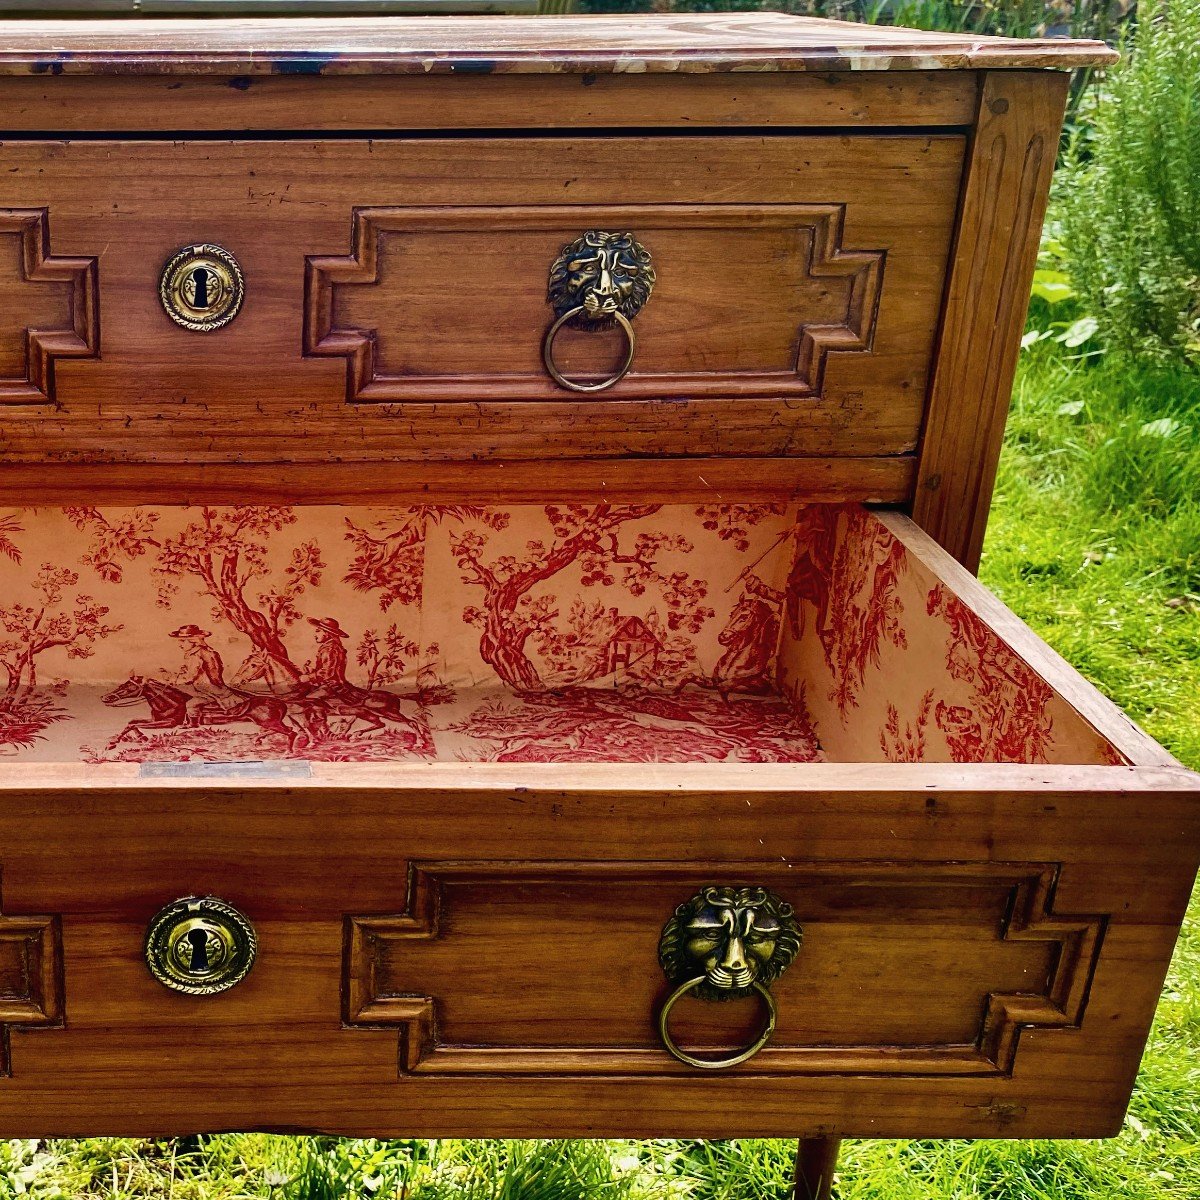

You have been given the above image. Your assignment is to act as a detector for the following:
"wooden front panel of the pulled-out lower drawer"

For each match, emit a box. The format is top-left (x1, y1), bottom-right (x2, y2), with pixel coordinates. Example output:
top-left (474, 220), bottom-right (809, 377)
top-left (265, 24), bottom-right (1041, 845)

top-left (0, 767), bottom-right (1200, 1136)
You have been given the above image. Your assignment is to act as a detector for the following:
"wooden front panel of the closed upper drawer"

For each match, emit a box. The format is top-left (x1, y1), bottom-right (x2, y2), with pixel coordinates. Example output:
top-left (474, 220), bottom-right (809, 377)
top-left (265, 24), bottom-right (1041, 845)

top-left (0, 136), bottom-right (964, 462)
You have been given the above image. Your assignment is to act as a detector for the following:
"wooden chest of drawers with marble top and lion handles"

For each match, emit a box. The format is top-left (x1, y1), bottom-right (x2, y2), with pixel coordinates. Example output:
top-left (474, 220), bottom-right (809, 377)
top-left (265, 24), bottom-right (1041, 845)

top-left (0, 14), bottom-right (1200, 1185)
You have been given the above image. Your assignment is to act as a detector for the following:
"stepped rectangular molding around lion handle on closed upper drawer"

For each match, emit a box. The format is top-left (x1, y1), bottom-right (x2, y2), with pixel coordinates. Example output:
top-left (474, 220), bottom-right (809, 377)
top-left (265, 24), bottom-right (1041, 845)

top-left (304, 204), bottom-right (886, 403)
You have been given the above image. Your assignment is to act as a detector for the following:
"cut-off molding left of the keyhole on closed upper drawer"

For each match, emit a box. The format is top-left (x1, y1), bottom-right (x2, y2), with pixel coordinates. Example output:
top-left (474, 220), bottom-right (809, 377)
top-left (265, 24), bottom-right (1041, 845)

top-left (0, 209), bottom-right (100, 404)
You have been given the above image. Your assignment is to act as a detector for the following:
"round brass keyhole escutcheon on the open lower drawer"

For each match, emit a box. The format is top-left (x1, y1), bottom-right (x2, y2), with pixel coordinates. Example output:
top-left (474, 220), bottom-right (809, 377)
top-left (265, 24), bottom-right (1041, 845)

top-left (145, 896), bottom-right (258, 996)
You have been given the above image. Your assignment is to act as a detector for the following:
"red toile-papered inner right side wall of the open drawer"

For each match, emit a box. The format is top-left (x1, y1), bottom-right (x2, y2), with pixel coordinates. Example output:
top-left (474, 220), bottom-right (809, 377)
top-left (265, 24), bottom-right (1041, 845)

top-left (778, 505), bottom-right (1123, 763)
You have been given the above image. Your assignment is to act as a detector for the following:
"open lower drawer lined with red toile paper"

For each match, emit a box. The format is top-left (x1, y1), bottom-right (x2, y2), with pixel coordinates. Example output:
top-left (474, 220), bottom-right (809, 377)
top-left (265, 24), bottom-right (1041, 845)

top-left (0, 503), bottom-right (1200, 1136)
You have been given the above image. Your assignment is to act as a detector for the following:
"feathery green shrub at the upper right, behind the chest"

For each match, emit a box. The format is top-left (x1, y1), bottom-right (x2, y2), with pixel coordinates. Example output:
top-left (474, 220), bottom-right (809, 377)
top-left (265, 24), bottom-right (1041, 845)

top-left (1060, 0), bottom-right (1200, 367)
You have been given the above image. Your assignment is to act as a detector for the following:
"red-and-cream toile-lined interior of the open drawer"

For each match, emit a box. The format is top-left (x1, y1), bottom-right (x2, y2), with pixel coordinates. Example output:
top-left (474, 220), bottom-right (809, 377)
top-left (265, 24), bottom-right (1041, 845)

top-left (0, 502), bottom-right (1127, 764)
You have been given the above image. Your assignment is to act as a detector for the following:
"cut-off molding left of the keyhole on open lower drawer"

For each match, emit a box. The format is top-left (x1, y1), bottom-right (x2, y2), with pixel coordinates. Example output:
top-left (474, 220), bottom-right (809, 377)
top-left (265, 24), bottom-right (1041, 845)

top-left (0, 916), bottom-right (64, 1076)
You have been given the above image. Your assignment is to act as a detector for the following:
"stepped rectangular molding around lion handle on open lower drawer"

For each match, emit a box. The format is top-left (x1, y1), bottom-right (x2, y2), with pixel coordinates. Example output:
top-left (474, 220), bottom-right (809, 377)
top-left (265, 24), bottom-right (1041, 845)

top-left (343, 862), bottom-right (1108, 1076)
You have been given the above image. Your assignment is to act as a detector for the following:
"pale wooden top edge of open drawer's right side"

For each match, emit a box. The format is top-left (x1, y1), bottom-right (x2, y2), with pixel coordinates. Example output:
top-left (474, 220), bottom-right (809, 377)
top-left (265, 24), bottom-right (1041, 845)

top-left (876, 512), bottom-right (1181, 767)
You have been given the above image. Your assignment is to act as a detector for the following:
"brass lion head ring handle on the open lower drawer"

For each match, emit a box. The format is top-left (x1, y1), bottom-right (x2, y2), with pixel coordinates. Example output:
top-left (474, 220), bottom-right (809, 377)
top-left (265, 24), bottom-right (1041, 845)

top-left (659, 887), bottom-right (804, 1070)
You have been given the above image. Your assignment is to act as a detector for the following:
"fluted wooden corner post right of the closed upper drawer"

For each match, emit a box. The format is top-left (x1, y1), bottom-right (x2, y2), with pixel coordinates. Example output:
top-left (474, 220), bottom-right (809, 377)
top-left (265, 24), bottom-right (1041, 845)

top-left (912, 73), bottom-right (1067, 570)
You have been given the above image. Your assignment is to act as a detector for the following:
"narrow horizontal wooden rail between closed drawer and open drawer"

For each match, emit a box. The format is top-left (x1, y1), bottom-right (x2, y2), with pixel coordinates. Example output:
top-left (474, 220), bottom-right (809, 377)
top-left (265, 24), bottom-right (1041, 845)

top-left (0, 455), bottom-right (916, 508)
